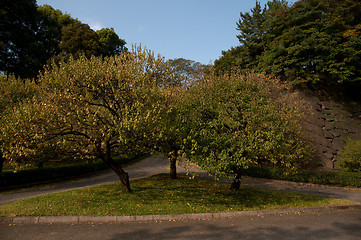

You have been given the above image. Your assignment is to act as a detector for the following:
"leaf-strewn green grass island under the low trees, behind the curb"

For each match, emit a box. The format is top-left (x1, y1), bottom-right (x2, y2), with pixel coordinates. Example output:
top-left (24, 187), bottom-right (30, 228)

top-left (0, 174), bottom-right (353, 216)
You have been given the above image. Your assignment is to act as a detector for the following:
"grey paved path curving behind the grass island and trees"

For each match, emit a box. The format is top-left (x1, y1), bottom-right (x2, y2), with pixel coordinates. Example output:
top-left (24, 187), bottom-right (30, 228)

top-left (0, 155), bottom-right (361, 205)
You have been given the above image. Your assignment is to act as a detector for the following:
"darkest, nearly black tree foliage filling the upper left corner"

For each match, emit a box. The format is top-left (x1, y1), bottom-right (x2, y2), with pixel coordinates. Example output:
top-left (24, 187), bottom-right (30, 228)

top-left (0, 0), bottom-right (78, 78)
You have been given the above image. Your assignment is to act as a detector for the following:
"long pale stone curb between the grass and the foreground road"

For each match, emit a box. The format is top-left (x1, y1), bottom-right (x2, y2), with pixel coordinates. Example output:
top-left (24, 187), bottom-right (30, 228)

top-left (0, 204), bottom-right (361, 224)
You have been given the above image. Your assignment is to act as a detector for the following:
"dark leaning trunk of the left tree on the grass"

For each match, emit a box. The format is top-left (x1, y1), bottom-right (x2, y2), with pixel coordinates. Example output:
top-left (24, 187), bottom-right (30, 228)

top-left (97, 142), bottom-right (132, 193)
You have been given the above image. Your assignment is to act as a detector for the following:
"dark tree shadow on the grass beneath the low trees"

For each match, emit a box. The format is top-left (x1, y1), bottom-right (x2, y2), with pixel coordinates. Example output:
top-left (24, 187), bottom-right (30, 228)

top-left (109, 174), bottom-right (332, 212)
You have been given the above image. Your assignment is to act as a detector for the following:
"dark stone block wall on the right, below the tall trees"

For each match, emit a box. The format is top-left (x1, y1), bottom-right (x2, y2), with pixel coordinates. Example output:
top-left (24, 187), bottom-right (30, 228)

top-left (299, 91), bottom-right (361, 170)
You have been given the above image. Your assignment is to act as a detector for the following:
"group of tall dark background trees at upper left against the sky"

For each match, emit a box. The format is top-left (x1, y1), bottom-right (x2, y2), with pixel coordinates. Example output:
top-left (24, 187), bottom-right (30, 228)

top-left (0, 0), bottom-right (126, 78)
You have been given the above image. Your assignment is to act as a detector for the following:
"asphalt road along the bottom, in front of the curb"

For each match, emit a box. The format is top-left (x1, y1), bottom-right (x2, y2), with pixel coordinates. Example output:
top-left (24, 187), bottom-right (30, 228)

top-left (0, 210), bottom-right (361, 240)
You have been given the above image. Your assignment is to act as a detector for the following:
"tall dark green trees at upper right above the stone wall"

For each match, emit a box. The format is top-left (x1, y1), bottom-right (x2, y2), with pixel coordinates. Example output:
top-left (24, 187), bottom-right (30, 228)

top-left (215, 0), bottom-right (361, 96)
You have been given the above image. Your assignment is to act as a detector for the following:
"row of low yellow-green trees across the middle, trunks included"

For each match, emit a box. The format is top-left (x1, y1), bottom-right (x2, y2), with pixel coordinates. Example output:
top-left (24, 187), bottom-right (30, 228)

top-left (0, 47), bottom-right (311, 192)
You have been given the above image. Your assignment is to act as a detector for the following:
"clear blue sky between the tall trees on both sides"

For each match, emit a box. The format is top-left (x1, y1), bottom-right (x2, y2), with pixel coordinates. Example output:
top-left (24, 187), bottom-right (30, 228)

top-left (37, 0), bottom-right (292, 64)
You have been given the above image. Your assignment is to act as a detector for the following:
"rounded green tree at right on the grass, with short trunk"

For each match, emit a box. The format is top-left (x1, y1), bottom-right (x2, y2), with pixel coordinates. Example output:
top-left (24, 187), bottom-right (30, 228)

top-left (181, 73), bottom-right (311, 189)
